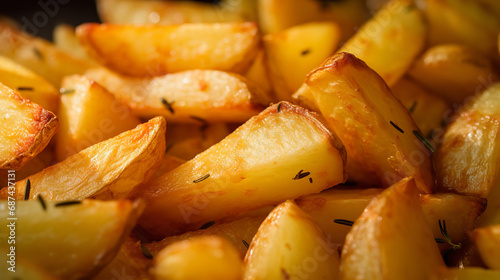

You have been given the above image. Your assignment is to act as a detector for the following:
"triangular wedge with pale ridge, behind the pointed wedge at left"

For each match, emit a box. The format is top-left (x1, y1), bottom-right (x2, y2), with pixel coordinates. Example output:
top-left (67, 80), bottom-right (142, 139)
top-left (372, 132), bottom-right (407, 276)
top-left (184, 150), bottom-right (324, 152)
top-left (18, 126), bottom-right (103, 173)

top-left (56, 75), bottom-right (141, 162)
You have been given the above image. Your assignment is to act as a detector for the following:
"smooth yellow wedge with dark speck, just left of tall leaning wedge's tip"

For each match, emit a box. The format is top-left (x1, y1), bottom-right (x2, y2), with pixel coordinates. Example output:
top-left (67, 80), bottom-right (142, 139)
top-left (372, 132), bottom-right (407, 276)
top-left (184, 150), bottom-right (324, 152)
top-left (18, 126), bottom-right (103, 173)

top-left (263, 22), bottom-right (340, 101)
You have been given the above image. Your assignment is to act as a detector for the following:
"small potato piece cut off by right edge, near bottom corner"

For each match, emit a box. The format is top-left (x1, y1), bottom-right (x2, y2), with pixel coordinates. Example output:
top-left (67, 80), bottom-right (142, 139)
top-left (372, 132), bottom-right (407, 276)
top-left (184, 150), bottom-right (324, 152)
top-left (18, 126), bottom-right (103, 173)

top-left (469, 224), bottom-right (500, 270)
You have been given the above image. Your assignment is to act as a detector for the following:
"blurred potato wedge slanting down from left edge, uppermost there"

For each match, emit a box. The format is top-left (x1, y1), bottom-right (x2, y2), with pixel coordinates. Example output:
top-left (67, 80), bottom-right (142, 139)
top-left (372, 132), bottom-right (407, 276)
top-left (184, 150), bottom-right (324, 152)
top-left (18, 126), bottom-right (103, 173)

top-left (0, 23), bottom-right (93, 87)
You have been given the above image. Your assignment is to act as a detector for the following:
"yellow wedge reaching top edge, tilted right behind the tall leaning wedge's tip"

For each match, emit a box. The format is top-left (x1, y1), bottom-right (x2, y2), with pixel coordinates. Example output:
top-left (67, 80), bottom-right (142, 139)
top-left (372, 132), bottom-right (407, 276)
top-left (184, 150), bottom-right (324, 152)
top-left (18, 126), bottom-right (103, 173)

top-left (340, 0), bottom-right (427, 86)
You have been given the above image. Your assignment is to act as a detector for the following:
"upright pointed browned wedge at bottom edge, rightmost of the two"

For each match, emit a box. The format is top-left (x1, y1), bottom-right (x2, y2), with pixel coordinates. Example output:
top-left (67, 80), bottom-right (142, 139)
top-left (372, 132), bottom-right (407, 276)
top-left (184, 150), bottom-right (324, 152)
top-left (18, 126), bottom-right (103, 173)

top-left (340, 178), bottom-right (445, 280)
